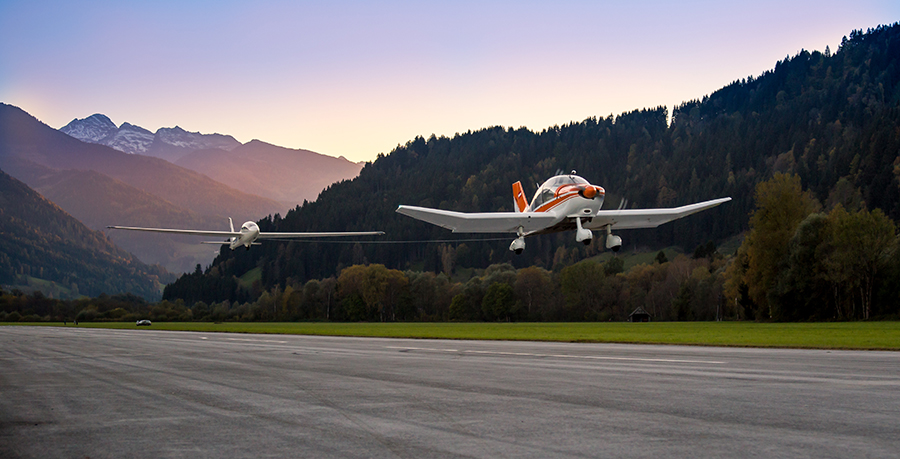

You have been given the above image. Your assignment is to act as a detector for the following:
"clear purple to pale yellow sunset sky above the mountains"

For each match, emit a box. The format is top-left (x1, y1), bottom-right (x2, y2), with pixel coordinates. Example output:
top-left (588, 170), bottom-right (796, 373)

top-left (0, 0), bottom-right (900, 161)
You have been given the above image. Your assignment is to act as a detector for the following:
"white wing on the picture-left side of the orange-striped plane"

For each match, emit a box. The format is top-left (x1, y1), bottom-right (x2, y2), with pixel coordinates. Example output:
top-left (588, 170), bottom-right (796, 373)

top-left (397, 206), bottom-right (563, 233)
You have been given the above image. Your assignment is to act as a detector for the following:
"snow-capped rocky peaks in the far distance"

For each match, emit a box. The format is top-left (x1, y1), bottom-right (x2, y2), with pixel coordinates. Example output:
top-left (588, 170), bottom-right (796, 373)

top-left (59, 113), bottom-right (241, 162)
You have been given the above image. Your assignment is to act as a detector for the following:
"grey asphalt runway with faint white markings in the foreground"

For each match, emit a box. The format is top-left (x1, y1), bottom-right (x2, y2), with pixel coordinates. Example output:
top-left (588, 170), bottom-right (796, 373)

top-left (0, 327), bottom-right (900, 458)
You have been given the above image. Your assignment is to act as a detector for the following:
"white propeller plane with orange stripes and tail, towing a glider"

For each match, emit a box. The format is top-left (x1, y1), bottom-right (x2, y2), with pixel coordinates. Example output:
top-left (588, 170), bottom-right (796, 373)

top-left (397, 171), bottom-right (731, 255)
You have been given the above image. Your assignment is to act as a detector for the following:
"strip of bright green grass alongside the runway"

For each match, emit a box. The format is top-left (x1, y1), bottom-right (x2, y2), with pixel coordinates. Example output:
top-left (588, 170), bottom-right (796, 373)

top-left (0, 322), bottom-right (900, 350)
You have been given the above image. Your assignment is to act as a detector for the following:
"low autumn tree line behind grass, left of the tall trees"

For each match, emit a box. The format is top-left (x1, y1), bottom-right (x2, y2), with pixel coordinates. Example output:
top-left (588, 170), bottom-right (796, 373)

top-left (0, 255), bottom-right (726, 322)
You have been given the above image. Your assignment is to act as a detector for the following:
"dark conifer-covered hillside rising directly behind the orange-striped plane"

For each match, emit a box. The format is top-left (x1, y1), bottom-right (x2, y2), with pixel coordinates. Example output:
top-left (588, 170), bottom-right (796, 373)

top-left (166, 24), bottom-right (900, 302)
